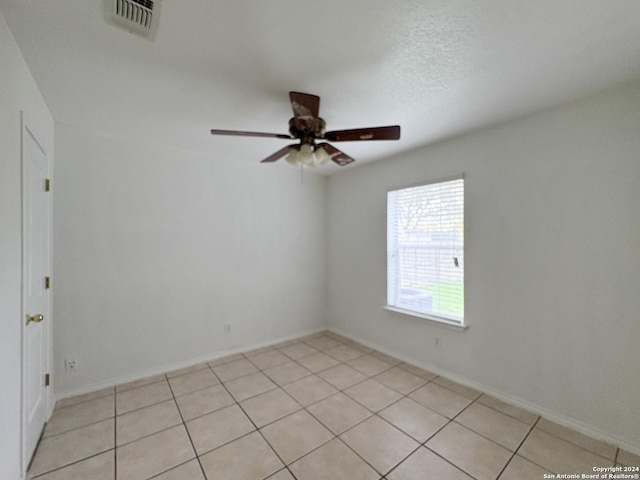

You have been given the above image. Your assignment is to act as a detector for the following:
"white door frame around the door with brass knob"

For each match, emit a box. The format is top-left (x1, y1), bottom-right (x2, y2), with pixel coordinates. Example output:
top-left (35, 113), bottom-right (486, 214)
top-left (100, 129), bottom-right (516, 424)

top-left (20, 111), bottom-right (54, 478)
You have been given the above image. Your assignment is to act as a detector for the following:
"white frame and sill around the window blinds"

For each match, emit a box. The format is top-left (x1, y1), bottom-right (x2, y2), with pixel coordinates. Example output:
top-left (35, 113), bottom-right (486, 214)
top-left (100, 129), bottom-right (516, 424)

top-left (383, 173), bottom-right (468, 330)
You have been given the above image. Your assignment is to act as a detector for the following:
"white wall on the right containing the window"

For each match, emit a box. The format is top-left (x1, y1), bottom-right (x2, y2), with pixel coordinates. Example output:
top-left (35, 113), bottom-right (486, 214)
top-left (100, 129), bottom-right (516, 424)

top-left (327, 83), bottom-right (640, 452)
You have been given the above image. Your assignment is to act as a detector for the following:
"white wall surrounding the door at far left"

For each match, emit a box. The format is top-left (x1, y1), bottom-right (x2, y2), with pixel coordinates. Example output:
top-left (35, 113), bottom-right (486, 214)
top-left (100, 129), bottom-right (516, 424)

top-left (0, 14), bottom-right (53, 479)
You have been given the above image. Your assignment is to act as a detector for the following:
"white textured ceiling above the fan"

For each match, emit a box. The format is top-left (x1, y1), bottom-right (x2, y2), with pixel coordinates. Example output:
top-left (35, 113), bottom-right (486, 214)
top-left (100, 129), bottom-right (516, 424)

top-left (0, 0), bottom-right (640, 173)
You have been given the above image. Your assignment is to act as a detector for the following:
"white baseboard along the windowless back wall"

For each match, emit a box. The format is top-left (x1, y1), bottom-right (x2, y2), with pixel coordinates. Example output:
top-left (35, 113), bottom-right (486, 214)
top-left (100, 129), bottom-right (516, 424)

top-left (51, 327), bottom-right (327, 402)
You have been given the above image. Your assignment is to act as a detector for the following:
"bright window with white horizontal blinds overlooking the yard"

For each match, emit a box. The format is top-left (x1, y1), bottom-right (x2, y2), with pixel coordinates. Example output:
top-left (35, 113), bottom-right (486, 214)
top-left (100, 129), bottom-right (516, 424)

top-left (387, 178), bottom-right (464, 326)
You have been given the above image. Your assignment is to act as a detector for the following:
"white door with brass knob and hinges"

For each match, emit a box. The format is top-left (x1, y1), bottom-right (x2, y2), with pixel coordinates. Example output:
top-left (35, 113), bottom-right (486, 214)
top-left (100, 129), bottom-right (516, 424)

top-left (22, 124), bottom-right (50, 467)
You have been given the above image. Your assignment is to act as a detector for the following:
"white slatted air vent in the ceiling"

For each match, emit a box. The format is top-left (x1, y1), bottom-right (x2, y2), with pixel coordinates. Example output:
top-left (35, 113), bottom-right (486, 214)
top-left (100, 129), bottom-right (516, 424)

top-left (105, 0), bottom-right (161, 39)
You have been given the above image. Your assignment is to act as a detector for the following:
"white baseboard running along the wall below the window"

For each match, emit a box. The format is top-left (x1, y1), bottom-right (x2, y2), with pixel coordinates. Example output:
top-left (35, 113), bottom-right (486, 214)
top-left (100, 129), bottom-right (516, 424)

top-left (327, 327), bottom-right (640, 455)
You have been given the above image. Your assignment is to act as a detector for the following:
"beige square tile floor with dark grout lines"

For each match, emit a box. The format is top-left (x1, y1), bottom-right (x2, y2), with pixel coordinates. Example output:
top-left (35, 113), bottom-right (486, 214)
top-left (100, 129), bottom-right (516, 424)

top-left (29, 332), bottom-right (640, 480)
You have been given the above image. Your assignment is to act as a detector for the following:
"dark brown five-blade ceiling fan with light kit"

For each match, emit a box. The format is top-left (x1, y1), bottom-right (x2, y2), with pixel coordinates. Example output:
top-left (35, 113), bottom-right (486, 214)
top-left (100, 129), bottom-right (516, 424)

top-left (211, 92), bottom-right (400, 168)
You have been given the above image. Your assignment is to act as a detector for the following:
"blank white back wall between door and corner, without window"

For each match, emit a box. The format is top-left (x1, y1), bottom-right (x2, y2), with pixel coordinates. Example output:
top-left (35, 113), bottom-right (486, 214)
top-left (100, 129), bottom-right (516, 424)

top-left (53, 123), bottom-right (326, 396)
